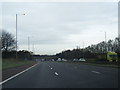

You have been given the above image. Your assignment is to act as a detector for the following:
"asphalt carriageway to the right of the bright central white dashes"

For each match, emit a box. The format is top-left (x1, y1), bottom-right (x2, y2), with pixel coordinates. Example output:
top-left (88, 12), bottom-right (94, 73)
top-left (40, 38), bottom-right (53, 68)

top-left (48, 63), bottom-right (118, 88)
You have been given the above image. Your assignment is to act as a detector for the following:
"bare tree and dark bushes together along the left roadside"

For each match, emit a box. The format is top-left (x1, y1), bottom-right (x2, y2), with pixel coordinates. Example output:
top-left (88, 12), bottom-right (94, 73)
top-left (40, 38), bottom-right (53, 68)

top-left (0, 30), bottom-right (33, 60)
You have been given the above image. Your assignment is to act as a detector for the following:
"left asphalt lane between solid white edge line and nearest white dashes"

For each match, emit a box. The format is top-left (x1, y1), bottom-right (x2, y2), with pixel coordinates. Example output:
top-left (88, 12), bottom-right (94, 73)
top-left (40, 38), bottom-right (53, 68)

top-left (3, 62), bottom-right (64, 88)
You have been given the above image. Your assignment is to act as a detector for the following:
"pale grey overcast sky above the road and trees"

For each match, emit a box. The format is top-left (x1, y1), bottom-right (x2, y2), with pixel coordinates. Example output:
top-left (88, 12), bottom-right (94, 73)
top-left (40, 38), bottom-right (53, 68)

top-left (2, 2), bottom-right (118, 54)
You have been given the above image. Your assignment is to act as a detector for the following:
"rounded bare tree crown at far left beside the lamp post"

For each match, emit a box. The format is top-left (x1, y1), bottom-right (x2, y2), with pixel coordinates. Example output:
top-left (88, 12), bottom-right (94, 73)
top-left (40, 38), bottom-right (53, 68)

top-left (1, 30), bottom-right (16, 52)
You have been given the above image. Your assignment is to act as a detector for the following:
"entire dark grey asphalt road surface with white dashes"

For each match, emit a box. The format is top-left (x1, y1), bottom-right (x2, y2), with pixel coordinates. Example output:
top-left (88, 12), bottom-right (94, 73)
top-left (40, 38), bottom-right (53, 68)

top-left (3, 62), bottom-right (118, 88)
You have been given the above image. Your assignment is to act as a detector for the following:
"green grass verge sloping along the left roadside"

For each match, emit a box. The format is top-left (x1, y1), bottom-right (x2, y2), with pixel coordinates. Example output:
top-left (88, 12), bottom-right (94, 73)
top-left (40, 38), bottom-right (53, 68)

top-left (2, 59), bottom-right (35, 70)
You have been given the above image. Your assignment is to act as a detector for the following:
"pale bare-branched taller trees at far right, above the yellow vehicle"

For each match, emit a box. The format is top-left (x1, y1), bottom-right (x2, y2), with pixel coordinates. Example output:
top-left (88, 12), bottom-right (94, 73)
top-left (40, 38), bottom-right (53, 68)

top-left (85, 37), bottom-right (120, 53)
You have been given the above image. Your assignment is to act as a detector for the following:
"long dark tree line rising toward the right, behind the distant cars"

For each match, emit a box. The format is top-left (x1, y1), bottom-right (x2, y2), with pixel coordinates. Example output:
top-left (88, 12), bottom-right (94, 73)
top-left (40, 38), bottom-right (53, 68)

top-left (56, 37), bottom-right (120, 60)
